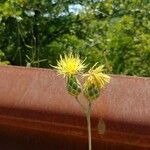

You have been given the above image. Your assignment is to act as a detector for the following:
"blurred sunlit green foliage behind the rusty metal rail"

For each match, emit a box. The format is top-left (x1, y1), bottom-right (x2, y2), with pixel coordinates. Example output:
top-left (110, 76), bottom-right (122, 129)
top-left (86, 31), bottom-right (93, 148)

top-left (0, 0), bottom-right (150, 76)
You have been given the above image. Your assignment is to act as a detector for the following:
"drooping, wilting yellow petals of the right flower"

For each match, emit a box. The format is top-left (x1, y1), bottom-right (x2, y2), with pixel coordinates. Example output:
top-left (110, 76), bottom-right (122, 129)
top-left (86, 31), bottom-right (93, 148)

top-left (84, 63), bottom-right (110, 88)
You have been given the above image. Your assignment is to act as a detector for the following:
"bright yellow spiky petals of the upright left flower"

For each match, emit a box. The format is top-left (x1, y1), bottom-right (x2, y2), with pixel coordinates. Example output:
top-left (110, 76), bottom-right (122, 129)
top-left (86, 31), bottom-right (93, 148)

top-left (55, 53), bottom-right (85, 76)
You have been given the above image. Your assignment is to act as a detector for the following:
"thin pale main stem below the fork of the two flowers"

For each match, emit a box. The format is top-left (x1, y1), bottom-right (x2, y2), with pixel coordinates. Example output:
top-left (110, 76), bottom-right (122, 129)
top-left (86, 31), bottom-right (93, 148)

top-left (86, 102), bottom-right (92, 150)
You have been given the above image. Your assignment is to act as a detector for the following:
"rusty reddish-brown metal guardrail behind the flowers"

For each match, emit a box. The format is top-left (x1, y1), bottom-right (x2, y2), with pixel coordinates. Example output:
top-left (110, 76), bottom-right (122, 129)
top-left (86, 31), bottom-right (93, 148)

top-left (0, 66), bottom-right (150, 150)
